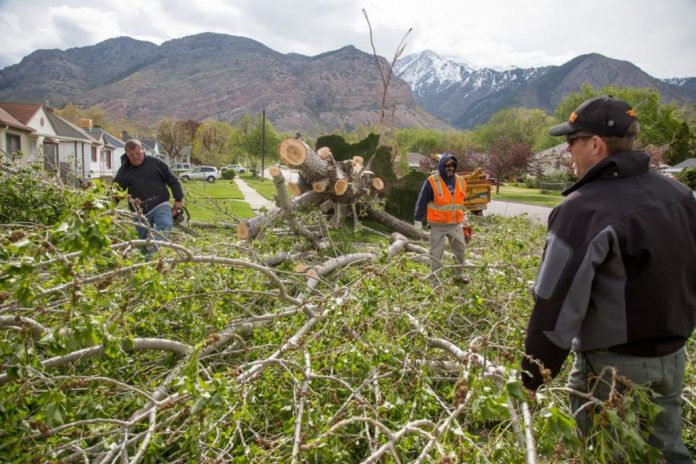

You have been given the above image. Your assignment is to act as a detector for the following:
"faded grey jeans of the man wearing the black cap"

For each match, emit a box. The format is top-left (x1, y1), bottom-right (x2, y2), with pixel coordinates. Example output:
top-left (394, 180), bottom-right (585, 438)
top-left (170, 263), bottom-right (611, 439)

top-left (568, 348), bottom-right (693, 463)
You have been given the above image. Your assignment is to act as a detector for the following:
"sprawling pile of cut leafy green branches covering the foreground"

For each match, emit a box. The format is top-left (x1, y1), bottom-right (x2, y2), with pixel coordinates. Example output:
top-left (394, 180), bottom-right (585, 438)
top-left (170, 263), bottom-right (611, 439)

top-left (0, 159), bottom-right (693, 463)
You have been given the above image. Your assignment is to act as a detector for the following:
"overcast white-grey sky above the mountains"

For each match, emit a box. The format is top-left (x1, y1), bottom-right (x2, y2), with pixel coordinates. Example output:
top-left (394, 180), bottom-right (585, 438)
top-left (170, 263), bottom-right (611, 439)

top-left (0, 0), bottom-right (696, 78)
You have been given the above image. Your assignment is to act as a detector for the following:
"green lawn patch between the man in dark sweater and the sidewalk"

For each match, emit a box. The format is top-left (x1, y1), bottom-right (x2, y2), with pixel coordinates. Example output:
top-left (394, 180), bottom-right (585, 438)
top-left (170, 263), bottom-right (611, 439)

top-left (182, 179), bottom-right (255, 222)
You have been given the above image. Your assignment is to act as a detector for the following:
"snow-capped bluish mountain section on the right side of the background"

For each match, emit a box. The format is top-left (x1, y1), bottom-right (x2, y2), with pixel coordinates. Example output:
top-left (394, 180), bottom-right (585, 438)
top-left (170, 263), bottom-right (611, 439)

top-left (395, 50), bottom-right (696, 128)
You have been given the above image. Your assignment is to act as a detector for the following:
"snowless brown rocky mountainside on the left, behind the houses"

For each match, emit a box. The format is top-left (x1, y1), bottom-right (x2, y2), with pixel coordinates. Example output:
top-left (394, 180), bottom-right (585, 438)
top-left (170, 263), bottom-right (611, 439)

top-left (0, 33), bottom-right (445, 133)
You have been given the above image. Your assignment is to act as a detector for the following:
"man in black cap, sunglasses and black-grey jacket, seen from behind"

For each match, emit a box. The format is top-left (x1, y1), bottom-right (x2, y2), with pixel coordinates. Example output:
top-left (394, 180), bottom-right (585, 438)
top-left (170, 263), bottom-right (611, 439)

top-left (522, 96), bottom-right (696, 463)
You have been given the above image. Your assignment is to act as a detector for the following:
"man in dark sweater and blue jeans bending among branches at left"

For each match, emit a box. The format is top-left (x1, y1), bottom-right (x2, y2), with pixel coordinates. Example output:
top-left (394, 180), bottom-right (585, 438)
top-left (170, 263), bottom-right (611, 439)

top-left (114, 139), bottom-right (184, 245)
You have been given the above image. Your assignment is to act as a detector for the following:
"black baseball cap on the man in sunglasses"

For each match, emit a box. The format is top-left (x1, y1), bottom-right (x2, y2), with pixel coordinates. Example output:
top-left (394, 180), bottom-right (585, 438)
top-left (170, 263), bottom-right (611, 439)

top-left (549, 95), bottom-right (636, 137)
